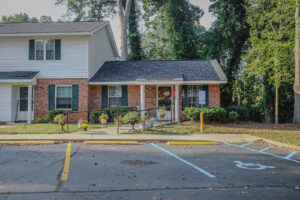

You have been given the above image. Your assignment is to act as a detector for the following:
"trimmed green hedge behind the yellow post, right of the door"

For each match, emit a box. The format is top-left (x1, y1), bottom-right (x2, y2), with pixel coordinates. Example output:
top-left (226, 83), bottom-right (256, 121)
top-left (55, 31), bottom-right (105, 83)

top-left (183, 107), bottom-right (226, 122)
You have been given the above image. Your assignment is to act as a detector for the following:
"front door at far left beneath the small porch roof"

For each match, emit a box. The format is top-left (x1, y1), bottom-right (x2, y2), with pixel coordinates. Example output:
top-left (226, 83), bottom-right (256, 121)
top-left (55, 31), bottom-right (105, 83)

top-left (17, 87), bottom-right (33, 121)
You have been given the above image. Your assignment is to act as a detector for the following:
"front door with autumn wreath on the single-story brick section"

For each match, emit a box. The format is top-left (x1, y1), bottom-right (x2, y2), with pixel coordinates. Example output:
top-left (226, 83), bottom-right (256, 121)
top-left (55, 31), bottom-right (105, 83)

top-left (157, 86), bottom-right (173, 121)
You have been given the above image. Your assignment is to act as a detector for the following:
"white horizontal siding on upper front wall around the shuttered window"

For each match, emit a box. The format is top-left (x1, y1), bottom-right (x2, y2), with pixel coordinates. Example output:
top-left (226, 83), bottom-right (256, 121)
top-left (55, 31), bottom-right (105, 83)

top-left (0, 36), bottom-right (89, 78)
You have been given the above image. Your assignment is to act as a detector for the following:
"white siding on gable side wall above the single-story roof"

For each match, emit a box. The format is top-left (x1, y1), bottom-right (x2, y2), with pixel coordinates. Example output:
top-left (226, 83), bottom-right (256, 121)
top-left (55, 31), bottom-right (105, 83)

top-left (88, 27), bottom-right (116, 78)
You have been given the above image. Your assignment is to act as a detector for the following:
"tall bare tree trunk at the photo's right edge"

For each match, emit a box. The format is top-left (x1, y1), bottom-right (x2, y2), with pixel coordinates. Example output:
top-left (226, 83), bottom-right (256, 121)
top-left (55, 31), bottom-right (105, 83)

top-left (293, 4), bottom-right (300, 124)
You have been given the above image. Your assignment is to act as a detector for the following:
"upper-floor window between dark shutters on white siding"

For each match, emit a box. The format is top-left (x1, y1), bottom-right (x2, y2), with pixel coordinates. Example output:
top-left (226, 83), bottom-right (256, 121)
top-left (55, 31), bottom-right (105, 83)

top-left (35, 40), bottom-right (55, 60)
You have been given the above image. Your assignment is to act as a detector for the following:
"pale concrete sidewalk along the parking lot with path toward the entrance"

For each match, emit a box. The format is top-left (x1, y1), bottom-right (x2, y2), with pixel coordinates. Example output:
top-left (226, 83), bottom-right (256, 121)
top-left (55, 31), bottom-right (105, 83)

top-left (0, 126), bottom-right (261, 142)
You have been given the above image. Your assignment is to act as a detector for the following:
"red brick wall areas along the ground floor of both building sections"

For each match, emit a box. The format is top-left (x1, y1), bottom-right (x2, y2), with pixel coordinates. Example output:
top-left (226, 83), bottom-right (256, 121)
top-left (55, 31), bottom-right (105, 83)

top-left (34, 82), bottom-right (220, 122)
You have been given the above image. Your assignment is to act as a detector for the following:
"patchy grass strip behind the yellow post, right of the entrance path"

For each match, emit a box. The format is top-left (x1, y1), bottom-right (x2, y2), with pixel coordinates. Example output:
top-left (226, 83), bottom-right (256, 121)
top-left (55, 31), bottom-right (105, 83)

top-left (144, 123), bottom-right (300, 146)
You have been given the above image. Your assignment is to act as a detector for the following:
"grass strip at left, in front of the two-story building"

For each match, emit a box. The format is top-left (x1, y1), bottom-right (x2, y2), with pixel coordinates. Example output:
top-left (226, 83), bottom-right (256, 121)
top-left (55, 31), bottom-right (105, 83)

top-left (0, 124), bottom-right (104, 134)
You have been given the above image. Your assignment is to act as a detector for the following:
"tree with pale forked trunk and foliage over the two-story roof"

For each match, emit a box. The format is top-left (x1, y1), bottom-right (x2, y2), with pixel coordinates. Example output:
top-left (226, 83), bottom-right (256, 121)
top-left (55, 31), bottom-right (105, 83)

top-left (55, 0), bottom-right (131, 60)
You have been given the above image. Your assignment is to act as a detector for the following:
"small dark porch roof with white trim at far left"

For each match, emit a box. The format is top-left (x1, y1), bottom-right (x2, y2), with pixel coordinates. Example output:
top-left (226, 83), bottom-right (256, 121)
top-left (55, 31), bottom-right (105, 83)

top-left (0, 71), bottom-right (39, 83)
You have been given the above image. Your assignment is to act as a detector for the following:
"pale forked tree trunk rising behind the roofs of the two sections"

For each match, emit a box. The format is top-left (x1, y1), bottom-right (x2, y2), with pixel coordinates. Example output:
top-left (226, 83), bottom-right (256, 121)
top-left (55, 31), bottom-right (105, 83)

top-left (117, 0), bottom-right (131, 61)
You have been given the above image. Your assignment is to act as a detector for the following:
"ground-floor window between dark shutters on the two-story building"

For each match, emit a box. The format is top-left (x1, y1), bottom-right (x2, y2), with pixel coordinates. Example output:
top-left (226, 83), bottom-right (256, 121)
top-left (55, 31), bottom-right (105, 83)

top-left (56, 86), bottom-right (72, 109)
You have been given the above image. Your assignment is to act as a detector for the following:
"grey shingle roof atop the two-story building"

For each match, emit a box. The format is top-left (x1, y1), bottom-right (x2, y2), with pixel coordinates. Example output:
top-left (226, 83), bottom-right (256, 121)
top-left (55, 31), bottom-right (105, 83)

top-left (0, 21), bottom-right (107, 34)
